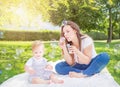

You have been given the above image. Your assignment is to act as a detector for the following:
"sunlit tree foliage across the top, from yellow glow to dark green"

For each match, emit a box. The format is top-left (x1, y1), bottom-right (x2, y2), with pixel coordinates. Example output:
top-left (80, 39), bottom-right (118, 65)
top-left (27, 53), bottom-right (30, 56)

top-left (0, 0), bottom-right (120, 38)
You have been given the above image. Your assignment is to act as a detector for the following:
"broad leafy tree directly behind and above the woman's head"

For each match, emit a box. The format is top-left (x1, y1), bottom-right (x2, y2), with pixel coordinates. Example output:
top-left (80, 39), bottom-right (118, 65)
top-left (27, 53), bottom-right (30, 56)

top-left (39, 0), bottom-right (102, 32)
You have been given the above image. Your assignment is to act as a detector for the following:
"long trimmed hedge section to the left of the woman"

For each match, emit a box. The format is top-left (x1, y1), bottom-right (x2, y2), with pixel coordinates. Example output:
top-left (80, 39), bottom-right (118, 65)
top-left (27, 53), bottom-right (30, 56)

top-left (0, 30), bottom-right (60, 41)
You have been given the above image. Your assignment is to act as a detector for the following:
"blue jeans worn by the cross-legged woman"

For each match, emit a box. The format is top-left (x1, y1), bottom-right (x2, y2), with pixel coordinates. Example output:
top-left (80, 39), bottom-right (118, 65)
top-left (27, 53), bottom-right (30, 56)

top-left (55, 53), bottom-right (110, 76)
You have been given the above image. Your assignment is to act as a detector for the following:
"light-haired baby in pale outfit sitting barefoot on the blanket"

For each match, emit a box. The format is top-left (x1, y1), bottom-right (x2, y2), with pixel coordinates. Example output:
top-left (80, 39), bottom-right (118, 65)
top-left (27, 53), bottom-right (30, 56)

top-left (25, 41), bottom-right (64, 84)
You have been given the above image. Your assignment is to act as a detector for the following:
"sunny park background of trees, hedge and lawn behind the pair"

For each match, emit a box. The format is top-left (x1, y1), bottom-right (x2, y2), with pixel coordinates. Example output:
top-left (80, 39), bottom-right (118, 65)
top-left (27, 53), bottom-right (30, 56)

top-left (0, 0), bottom-right (120, 84)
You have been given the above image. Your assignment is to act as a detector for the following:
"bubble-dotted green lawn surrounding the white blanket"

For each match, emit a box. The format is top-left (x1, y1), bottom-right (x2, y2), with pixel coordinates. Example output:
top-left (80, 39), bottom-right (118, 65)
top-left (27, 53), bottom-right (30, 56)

top-left (0, 40), bottom-right (120, 84)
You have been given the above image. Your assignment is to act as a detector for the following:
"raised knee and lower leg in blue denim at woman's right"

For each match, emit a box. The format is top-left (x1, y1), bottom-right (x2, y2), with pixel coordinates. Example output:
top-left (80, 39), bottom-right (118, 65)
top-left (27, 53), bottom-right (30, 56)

top-left (83, 53), bottom-right (109, 76)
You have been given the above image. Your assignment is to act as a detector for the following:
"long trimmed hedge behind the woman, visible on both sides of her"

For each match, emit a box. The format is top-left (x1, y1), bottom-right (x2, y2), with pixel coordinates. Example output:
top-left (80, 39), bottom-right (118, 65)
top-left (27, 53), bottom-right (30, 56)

top-left (0, 30), bottom-right (119, 41)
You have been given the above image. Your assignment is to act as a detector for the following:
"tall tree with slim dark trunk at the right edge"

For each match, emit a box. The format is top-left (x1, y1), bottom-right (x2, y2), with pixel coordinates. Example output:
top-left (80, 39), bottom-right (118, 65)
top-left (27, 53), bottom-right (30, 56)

top-left (96, 0), bottom-right (120, 43)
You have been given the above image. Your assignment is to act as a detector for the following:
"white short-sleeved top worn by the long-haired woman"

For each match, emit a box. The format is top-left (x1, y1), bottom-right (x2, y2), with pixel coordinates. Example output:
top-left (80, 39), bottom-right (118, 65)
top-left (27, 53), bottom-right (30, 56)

top-left (74, 36), bottom-right (97, 63)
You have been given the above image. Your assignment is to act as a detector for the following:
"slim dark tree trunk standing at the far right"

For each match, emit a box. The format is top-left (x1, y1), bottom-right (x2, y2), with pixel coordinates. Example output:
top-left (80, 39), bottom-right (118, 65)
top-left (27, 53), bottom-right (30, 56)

top-left (107, 7), bottom-right (112, 43)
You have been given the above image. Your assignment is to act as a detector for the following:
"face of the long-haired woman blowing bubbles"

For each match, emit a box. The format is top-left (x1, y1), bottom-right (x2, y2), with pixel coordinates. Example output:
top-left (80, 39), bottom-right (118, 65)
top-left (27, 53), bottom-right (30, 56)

top-left (63, 25), bottom-right (76, 41)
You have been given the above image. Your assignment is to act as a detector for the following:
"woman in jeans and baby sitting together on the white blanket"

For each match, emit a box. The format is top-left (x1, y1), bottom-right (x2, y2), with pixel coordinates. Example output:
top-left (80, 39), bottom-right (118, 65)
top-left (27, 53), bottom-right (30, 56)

top-left (25, 21), bottom-right (109, 84)
